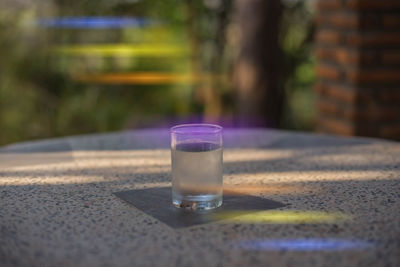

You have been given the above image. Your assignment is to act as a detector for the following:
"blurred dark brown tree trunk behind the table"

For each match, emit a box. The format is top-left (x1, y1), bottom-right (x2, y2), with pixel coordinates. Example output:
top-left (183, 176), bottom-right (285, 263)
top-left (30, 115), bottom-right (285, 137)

top-left (234, 0), bottom-right (284, 127)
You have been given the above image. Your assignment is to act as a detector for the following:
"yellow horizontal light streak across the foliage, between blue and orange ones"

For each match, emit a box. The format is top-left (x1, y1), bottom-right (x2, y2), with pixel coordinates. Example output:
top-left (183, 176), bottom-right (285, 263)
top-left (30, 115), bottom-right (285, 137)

top-left (51, 44), bottom-right (189, 57)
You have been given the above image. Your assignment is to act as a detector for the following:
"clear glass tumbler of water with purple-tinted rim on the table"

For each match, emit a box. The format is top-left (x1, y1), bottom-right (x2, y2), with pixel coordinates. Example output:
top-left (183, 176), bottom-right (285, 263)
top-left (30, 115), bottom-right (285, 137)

top-left (171, 124), bottom-right (222, 210)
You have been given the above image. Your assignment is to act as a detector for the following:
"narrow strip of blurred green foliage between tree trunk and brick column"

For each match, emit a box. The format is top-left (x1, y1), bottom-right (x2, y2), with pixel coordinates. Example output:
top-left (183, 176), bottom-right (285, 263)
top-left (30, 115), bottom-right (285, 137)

top-left (281, 0), bottom-right (315, 131)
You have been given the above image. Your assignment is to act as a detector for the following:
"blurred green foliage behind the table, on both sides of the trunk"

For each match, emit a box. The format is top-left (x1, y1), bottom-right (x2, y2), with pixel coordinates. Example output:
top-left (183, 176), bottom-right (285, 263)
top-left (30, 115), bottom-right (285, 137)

top-left (0, 0), bottom-right (314, 145)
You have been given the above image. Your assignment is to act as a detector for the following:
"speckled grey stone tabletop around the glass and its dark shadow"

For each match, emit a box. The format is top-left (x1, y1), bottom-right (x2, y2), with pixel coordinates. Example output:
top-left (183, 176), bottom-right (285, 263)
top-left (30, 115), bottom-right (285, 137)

top-left (0, 130), bottom-right (400, 266)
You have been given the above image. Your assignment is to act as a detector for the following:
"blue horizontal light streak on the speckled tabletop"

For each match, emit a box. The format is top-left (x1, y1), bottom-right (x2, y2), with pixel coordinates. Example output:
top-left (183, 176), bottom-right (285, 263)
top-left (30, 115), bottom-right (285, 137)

top-left (235, 238), bottom-right (375, 251)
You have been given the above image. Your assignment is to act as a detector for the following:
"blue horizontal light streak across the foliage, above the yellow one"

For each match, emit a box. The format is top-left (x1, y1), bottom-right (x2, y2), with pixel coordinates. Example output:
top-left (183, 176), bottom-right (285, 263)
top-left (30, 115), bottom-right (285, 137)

top-left (37, 17), bottom-right (155, 29)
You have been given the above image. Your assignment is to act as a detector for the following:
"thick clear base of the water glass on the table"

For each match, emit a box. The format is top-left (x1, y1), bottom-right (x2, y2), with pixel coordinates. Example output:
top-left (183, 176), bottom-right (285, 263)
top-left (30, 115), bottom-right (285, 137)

top-left (172, 191), bottom-right (222, 210)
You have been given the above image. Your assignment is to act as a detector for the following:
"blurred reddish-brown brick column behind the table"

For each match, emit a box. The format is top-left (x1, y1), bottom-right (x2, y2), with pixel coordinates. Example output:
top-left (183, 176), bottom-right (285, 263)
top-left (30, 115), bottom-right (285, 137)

top-left (314, 0), bottom-right (400, 140)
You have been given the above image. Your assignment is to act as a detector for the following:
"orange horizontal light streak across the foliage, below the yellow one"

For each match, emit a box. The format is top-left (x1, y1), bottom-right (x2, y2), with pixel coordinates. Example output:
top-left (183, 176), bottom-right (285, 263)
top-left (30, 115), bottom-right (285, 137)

top-left (75, 72), bottom-right (216, 84)
